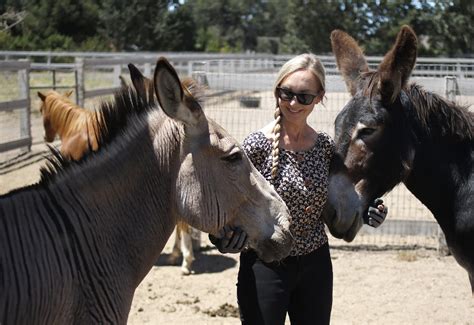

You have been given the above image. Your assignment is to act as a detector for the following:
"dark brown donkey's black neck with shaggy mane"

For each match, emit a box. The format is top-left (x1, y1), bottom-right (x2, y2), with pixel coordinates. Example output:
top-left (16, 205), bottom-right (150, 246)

top-left (402, 84), bottom-right (473, 225)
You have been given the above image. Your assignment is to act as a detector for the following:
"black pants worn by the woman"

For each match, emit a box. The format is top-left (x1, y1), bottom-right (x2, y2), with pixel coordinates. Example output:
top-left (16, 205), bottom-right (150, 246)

top-left (237, 244), bottom-right (333, 325)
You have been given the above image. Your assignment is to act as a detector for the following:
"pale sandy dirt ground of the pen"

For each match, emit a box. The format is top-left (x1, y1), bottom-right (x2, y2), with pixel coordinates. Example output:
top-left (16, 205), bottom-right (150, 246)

top-left (0, 151), bottom-right (474, 325)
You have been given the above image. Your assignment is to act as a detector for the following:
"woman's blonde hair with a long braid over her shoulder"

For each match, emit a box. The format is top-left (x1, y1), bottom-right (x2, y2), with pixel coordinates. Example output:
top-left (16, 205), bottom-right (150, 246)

top-left (271, 53), bottom-right (326, 179)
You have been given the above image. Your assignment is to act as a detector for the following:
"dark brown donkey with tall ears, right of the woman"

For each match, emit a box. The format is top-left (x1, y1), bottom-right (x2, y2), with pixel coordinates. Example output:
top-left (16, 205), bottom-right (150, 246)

top-left (331, 26), bottom-right (474, 293)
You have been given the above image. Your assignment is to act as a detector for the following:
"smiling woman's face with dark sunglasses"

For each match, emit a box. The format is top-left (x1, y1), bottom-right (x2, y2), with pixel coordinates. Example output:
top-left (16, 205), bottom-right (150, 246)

top-left (277, 70), bottom-right (324, 124)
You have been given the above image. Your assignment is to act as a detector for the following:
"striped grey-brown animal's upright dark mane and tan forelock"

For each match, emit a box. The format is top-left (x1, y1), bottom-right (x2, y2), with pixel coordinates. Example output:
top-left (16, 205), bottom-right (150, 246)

top-left (39, 78), bottom-right (204, 184)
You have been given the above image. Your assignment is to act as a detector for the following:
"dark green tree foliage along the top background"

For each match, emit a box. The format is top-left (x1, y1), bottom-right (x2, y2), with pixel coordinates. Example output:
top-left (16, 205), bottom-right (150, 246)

top-left (0, 0), bottom-right (474, 56)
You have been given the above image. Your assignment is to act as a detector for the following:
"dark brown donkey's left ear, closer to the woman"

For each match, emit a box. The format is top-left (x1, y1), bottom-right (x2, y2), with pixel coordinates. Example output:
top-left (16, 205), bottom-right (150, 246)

top-left (331, 29), bottom-right (369, 96)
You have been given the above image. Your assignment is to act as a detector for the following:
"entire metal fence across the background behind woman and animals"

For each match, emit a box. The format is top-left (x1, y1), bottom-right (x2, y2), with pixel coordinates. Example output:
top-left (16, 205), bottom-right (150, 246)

top-left (0, 52), bottom-right (474, 248)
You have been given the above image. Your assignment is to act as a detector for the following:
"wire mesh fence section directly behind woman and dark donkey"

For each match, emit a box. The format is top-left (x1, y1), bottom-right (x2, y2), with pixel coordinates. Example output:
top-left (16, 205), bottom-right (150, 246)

top-left (195, 73), bottom-right (474, 248)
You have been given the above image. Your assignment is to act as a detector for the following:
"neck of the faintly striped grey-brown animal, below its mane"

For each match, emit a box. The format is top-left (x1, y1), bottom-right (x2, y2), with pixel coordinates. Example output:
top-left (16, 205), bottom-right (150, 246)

top-left (47, 114), bottom-right (178, 285)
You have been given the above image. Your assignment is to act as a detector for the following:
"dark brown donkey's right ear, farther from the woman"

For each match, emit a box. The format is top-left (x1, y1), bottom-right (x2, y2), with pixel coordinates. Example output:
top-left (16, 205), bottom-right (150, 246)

top-left (378, 25), bottom-right (418, 104)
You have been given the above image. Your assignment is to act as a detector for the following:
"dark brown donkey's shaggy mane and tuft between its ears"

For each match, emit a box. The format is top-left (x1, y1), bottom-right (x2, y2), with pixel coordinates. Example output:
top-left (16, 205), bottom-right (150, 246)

top-left (361, 71), bottom-right (474, 141)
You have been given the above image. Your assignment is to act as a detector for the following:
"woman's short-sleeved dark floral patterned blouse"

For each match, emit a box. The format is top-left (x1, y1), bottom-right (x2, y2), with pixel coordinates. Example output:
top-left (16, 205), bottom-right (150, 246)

top-left (243, 131), bottom-right (334, 256)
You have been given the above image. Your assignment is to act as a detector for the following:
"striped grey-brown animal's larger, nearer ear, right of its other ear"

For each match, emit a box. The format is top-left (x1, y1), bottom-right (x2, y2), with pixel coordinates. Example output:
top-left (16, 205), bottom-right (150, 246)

top-left (154, 57), bottom-right (203, 126)
